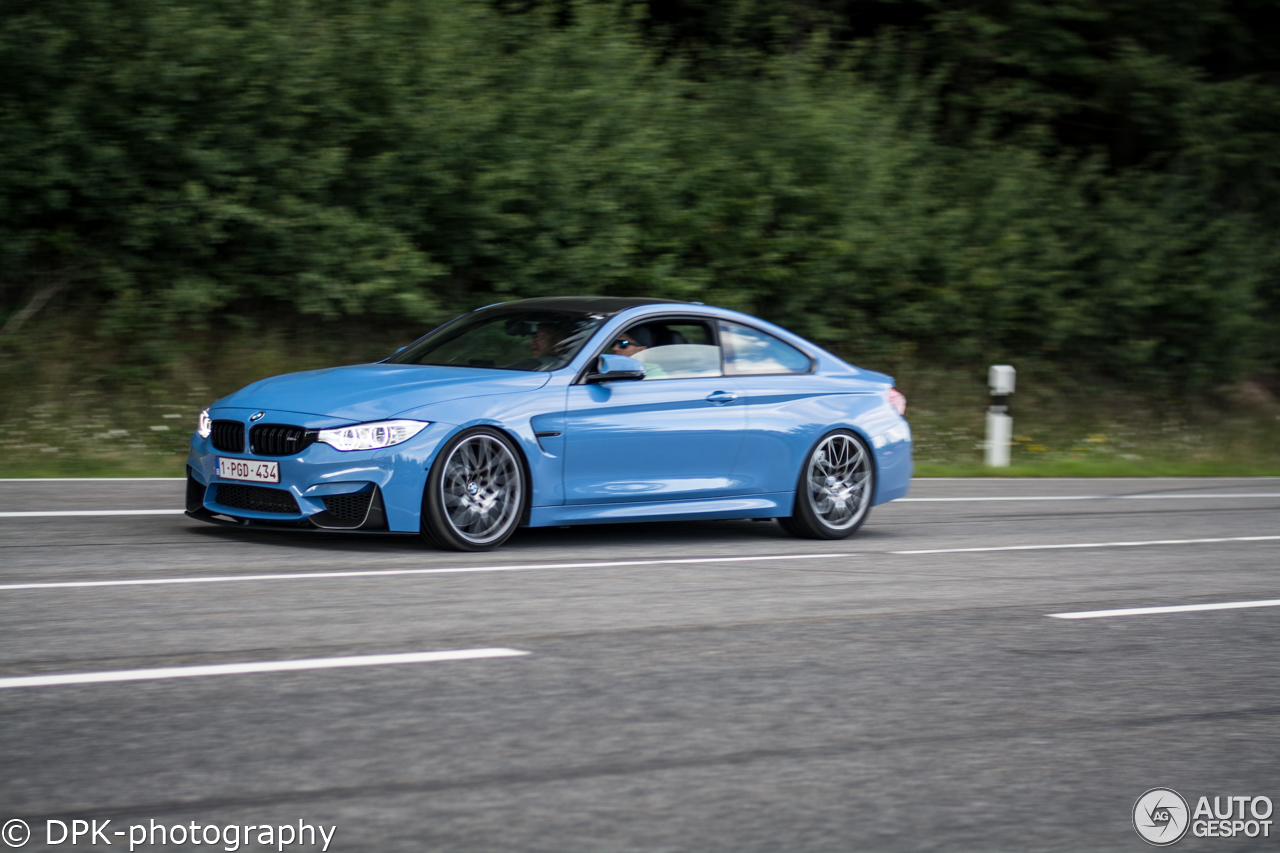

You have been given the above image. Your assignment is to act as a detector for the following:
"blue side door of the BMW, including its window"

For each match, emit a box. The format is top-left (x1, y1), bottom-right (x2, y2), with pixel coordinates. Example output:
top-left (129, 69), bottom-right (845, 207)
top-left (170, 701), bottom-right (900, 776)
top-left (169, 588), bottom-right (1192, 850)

top-left (564, 318), bottom-right (746, 505)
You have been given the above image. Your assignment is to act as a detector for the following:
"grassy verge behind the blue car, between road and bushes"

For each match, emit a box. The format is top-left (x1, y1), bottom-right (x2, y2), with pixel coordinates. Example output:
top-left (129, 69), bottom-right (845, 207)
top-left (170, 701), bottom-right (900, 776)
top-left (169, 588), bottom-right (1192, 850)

top-left (0, 323), bottom-right (1280, 478)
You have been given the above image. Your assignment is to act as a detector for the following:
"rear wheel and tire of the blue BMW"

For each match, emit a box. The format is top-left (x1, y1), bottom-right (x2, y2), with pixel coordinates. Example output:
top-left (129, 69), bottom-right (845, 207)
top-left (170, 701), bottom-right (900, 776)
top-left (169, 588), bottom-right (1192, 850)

top-left (778, 429), bottom-right (876, 539)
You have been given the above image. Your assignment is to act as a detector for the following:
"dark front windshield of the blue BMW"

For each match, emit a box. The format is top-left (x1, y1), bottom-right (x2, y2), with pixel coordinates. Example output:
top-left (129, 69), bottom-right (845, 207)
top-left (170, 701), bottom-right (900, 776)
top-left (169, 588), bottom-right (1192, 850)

top-left (388, 309), bottom-right (604, 371)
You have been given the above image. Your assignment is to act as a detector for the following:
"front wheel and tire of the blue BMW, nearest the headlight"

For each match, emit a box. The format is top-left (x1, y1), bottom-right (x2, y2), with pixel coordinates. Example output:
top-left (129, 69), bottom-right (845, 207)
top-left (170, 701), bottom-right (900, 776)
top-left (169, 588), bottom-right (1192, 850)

top-left (421, 427), bottom-right (529, 551)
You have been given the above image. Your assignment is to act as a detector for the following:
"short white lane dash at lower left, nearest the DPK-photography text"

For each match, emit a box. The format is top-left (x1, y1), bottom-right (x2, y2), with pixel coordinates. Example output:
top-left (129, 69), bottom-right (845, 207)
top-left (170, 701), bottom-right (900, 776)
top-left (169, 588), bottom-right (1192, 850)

top-left (0, 648), bottom-right (529, 689)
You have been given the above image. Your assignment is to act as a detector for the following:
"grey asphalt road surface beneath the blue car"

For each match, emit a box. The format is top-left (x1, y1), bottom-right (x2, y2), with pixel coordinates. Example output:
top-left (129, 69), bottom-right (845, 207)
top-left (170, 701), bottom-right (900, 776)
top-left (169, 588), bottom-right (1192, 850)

top-left (0, 478), bottom-right (1280, 853)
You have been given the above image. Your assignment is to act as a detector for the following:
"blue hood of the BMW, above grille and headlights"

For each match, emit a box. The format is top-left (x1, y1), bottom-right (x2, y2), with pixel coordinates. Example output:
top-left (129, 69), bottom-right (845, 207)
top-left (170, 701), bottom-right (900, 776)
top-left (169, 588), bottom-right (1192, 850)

top-left (216, 364), bottom-right (550, 423)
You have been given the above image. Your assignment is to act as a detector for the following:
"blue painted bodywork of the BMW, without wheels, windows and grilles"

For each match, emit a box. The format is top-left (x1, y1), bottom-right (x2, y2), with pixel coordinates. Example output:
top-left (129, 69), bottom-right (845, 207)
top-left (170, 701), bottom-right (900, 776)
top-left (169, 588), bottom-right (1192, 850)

top-left (188, 298), bottom-right (911, 533)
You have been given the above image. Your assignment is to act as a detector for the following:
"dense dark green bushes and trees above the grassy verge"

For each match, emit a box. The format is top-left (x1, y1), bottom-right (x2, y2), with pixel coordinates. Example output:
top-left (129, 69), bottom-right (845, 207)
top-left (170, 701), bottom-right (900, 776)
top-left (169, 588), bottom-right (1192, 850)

top-left (0, 0), bottom-right (1280, 388)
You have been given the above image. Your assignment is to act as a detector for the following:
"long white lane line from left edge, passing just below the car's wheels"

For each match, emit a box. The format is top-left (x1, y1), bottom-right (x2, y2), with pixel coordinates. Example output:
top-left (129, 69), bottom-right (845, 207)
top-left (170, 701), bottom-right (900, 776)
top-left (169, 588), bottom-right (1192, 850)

top-left (0, 553), bottom-right (860, 590)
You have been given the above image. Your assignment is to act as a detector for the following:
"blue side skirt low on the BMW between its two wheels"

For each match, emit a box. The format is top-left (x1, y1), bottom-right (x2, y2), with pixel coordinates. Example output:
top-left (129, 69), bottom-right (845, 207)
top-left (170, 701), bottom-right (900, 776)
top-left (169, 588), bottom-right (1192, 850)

top-left (529, 492), bottom-right (795, 528)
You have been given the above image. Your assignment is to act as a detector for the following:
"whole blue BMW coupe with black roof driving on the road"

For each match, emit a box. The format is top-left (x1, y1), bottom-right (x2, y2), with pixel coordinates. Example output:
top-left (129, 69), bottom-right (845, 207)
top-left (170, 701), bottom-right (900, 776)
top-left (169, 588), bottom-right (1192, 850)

top-left (187, 296), bottom-right (911, 551)
